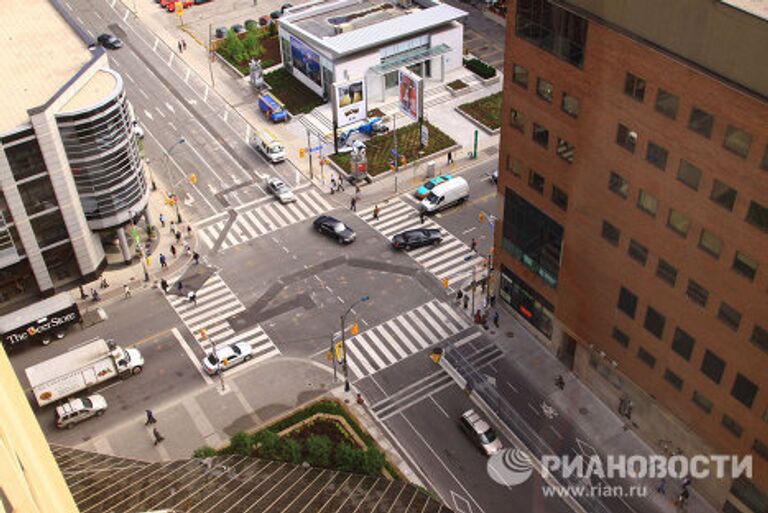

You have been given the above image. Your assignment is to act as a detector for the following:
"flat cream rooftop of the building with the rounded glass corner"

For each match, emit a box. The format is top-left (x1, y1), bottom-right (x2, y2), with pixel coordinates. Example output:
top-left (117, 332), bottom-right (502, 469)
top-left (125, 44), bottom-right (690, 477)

top-left (0, 0), bottom-right (92, 133)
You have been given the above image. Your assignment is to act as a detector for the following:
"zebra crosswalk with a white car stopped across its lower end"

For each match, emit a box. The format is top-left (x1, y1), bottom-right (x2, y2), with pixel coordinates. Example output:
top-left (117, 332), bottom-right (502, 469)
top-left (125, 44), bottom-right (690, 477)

top-left (166, 274), bottom-right (280, 361)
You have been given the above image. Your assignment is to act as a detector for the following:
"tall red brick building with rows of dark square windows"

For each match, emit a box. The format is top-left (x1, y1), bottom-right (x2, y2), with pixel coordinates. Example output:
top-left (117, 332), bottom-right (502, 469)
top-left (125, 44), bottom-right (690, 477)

top-left (495, 0), bottom-right (768, 506)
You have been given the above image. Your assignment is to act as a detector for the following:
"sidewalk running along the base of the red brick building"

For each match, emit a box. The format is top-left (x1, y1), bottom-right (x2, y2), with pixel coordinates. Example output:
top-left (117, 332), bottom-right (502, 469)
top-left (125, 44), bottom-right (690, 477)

top-left (465, 287), bottom-right (718, 513)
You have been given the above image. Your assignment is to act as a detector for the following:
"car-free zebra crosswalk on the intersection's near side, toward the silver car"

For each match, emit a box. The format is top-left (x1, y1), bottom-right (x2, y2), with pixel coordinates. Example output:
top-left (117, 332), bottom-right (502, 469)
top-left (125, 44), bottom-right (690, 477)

top-left (346, 299), bottom-right (470, 379)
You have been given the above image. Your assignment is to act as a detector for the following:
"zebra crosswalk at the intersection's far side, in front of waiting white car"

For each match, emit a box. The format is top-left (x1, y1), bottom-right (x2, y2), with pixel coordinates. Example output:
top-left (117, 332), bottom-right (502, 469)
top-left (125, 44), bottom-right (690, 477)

top-left (197, 189), bottom-right (333, 249)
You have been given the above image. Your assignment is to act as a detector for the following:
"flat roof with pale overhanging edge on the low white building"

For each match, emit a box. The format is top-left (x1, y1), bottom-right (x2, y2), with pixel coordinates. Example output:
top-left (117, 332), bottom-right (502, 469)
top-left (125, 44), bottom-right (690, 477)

top-left (280, 0), bottom-right (467, 55)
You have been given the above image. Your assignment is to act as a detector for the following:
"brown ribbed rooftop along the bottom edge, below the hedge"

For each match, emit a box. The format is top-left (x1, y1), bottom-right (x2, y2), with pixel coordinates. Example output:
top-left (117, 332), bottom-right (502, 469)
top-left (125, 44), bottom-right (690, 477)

top-left (51, 446), bottom-right (450, 513)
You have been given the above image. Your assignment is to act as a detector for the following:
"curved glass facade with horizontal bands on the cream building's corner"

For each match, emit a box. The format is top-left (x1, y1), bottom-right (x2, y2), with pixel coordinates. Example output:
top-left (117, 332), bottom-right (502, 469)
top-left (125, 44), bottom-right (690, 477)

top-left (56, 71), bottom-right (148, 229)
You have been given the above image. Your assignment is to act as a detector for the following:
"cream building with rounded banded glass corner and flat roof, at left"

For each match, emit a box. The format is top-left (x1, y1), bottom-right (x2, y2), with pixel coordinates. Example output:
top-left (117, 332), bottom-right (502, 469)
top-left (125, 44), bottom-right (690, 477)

top-left (0, 0), bottom-right (149, 307)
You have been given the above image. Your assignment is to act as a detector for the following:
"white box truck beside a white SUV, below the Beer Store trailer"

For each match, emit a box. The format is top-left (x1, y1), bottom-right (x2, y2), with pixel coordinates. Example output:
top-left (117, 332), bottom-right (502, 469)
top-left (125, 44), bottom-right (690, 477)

top-left (25, 338), bottom-right (144, 406)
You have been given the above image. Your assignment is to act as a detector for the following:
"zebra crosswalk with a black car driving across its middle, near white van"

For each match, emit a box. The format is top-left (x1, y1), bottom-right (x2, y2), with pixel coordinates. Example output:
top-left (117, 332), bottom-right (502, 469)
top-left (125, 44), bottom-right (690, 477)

top-left (358, 199), bottom-right (486, 287)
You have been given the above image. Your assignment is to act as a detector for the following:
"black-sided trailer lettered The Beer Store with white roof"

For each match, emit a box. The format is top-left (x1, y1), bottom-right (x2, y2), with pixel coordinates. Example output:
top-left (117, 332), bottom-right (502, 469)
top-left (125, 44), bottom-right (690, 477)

top-left (0, 292), bottom-right (80, 349)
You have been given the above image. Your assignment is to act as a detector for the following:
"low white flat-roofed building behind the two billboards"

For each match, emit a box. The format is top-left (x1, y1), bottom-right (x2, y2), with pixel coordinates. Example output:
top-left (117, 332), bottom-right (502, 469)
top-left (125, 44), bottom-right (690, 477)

top-left (279, 0), bottom-right (467, 101)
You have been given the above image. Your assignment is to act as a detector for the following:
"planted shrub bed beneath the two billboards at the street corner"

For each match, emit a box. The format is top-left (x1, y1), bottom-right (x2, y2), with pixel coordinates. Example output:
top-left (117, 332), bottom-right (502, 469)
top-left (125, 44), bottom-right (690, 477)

top-left (331, 121), bottom-right (456, 176)
